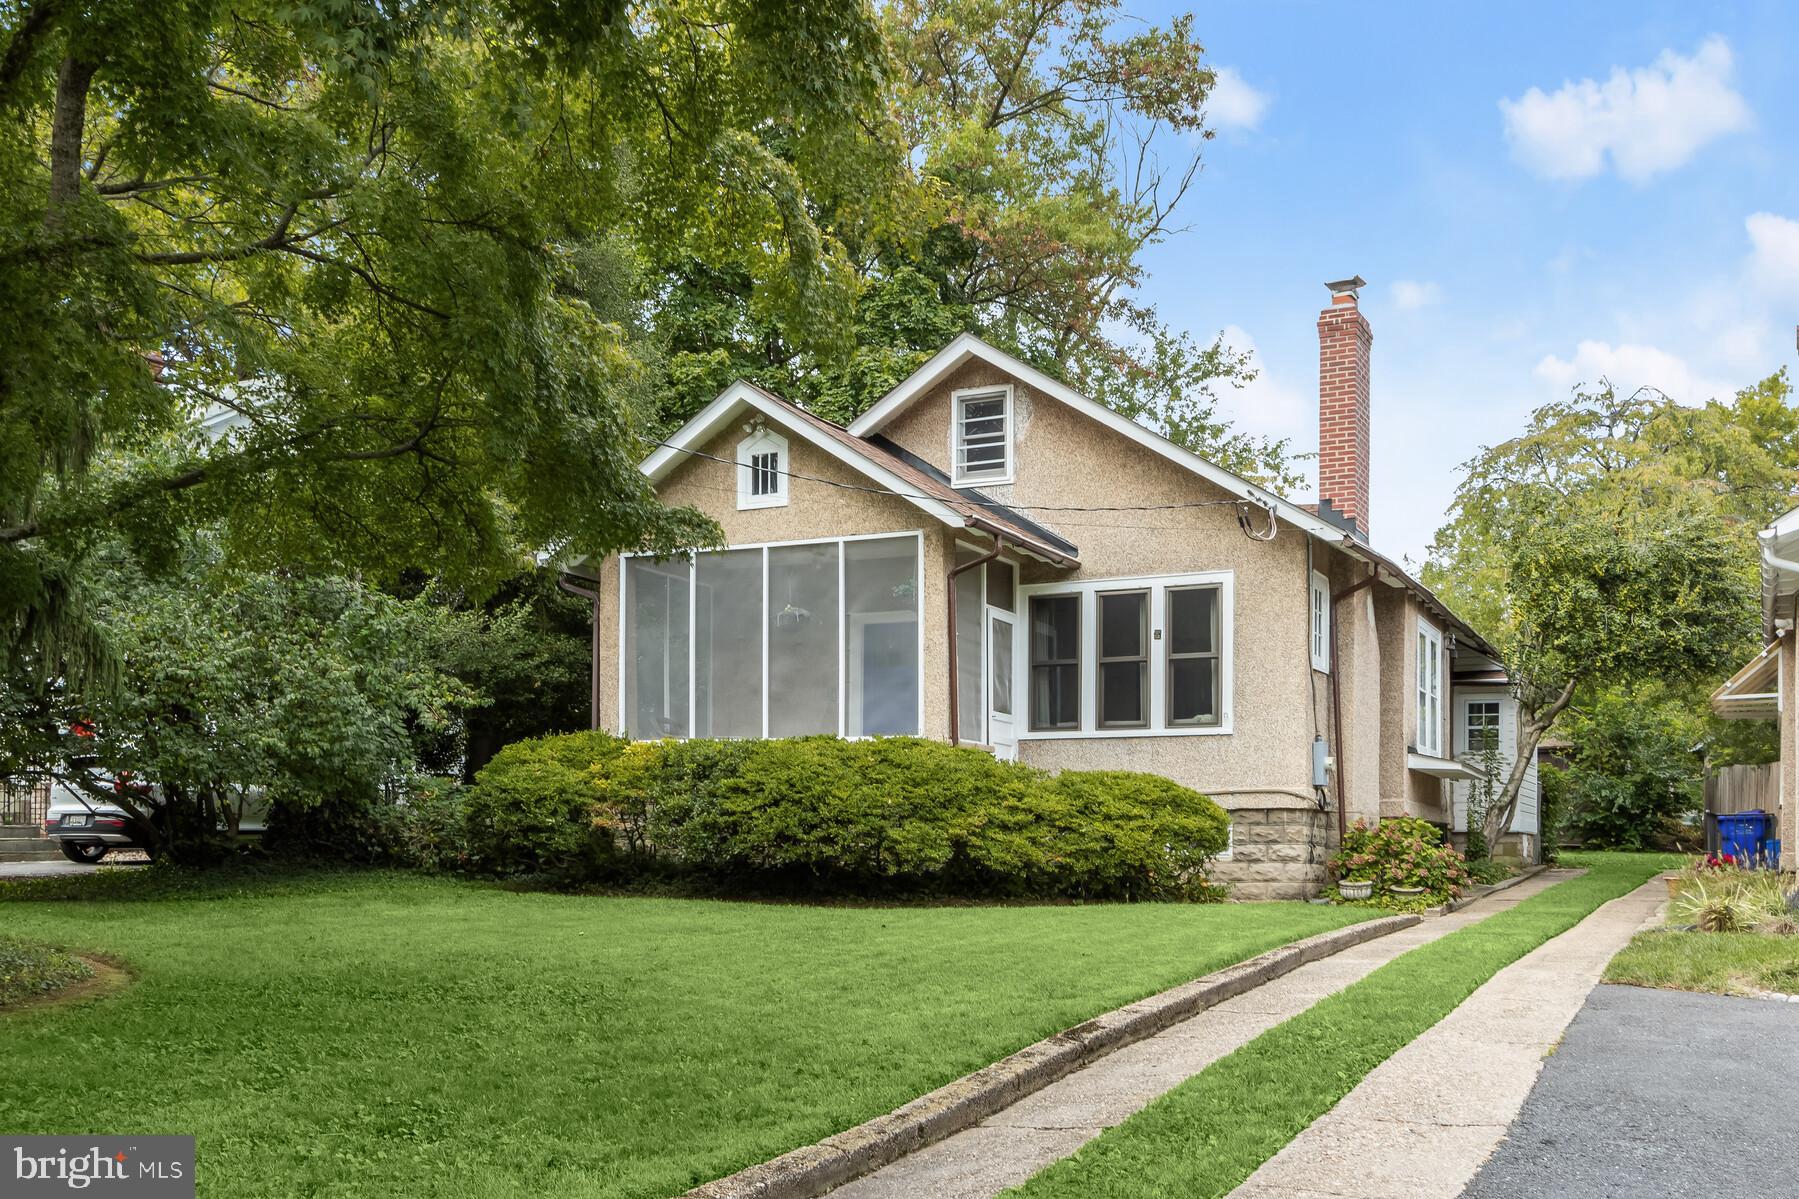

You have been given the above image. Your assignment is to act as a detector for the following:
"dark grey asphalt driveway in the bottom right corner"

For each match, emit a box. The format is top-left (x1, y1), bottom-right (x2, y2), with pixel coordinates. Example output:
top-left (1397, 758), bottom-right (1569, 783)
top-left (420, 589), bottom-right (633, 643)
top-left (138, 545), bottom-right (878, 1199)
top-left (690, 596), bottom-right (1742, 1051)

top-left (1463, 987), bottom-right (1799, 1199)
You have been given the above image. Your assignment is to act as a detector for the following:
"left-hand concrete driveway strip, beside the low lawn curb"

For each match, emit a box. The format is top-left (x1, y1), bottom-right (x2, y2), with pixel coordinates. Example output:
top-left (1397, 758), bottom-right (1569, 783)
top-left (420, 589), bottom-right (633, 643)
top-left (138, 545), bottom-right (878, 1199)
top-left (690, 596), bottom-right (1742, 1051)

top-left (829, 870), bottom-right (1575, 1199)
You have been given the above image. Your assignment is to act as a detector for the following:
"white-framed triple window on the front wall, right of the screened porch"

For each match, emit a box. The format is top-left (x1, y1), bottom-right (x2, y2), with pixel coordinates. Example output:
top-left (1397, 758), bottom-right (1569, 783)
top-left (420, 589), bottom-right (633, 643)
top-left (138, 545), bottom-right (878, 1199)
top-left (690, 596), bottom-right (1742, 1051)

top-left (1020, 572), bottom-right (1232, 738)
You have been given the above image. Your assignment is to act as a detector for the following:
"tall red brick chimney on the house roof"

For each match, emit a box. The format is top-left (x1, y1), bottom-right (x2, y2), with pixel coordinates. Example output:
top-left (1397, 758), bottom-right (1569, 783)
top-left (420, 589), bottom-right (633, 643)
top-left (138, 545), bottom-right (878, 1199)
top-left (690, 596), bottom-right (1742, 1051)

top-left (1319, 275), bottom-right (1374, 542)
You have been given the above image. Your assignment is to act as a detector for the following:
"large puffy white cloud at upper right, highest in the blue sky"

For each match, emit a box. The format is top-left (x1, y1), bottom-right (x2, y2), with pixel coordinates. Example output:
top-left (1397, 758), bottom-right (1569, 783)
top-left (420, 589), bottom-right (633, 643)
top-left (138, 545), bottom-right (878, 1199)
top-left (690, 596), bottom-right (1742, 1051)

top-left (1499, 36), bottom-right (1749, 184)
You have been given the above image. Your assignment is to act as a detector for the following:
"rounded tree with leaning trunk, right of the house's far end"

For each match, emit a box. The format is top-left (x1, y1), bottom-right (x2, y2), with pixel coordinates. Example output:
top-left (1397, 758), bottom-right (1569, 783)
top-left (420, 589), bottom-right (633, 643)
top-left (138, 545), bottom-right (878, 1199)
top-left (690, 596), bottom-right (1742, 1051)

top-left (1425, 373), bottom-right (1799, 844)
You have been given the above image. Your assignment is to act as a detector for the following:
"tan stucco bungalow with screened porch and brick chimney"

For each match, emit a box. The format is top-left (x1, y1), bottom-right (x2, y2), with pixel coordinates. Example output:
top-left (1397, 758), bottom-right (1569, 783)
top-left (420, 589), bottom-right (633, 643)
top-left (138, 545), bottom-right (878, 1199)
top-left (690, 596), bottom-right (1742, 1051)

top-left (585, 279), bottom-right (1535, 885)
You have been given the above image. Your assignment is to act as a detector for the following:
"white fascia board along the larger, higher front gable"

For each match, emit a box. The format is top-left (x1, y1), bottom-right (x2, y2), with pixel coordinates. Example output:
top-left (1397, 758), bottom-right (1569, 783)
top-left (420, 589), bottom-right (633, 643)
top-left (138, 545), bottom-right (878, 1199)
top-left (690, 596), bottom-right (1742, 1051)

top-left (849, 333), bottom-right (1351, 544)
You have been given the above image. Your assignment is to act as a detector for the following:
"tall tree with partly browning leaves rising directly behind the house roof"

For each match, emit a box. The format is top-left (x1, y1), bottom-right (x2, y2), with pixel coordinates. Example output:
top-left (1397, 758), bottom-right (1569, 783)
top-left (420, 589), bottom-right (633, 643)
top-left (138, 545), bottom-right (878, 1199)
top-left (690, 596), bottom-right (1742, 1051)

top-left (651, 0), bottom-right (1297, 486)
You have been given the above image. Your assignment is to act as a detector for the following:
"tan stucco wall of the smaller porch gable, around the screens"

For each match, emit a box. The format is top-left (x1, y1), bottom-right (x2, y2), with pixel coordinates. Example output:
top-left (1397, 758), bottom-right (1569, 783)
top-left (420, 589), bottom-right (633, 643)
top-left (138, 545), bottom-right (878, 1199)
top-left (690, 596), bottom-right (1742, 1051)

top-left (599, 421), bottom-right (950, 736)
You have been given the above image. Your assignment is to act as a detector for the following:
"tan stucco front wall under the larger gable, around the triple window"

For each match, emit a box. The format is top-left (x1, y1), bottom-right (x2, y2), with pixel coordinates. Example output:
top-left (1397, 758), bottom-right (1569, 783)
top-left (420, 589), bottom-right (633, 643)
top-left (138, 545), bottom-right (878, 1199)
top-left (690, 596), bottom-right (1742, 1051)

top-left (882, 354), bottom-right (1315, 808)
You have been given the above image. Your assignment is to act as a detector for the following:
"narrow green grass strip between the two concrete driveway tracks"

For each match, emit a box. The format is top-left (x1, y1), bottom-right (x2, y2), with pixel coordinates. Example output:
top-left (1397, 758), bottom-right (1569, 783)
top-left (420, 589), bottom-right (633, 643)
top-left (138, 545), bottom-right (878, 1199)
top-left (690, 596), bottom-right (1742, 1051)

top-left (1006, 853), bottom-right (1680, 1199)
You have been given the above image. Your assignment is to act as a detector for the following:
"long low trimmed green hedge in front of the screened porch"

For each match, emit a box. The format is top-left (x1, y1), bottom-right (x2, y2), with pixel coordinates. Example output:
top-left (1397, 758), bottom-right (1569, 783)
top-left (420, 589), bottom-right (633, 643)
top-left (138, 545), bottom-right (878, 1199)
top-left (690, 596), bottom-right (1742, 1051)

top-left (468, 733), bottom-right (1227, 898)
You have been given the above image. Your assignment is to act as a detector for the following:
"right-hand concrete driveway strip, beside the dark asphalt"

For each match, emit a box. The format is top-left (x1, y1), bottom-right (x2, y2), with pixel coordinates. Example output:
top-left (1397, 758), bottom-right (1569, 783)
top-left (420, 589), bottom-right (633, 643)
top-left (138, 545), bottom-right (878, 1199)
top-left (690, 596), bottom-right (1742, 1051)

top-left (1231, 867), bottom-right (1662, 1199)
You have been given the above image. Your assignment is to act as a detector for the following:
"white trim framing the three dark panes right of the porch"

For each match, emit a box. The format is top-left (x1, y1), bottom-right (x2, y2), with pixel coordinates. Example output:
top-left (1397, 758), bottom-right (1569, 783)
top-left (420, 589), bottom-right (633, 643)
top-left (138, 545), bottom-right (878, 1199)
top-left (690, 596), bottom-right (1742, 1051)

top-left (1013, 571), bottom-right (1236, 742)
